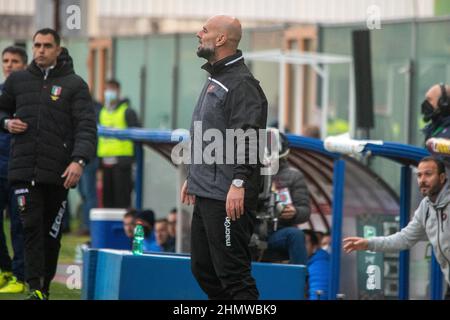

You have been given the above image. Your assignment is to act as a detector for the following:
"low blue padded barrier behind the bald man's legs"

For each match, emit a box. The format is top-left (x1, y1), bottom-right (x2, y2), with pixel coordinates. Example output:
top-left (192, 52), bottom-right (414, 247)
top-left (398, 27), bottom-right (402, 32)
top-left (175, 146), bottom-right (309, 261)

top-left (82, 249), bottom-right (306, 300)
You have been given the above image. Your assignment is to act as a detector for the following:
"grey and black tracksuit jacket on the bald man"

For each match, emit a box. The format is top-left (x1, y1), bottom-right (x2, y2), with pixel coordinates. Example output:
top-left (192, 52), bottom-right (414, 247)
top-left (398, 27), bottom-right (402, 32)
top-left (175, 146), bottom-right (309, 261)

top-left (187, 50), bottom-right (267, 209)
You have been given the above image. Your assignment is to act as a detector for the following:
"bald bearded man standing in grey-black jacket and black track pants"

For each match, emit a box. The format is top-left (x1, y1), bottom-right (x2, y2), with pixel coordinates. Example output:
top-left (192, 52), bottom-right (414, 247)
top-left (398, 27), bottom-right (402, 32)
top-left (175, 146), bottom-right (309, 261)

top-left (181, 16), bottom-right (267, 299)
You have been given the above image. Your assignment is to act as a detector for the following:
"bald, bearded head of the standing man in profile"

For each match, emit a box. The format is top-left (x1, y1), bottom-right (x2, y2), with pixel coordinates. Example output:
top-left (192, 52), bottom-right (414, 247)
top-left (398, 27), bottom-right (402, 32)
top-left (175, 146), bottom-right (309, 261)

top-left (197, 15), bottom-right (242, 64)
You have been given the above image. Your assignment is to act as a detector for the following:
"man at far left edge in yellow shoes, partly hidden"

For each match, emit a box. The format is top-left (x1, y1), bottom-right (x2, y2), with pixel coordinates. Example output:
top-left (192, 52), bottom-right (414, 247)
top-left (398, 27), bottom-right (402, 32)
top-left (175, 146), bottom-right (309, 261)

top-left (0, 47), bottom-right (28, 293)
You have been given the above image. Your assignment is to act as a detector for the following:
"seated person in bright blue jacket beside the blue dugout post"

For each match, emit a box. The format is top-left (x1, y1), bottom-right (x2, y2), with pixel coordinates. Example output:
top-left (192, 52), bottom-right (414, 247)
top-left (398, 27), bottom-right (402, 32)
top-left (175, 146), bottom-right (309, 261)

top-left (303, 230), bottom-right (330, 300)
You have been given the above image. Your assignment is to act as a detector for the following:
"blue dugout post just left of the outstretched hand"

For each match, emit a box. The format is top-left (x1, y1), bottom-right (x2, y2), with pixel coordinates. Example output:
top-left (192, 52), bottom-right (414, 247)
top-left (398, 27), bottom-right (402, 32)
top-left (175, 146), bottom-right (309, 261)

top-left (328, 159), bottom-right (345, 300)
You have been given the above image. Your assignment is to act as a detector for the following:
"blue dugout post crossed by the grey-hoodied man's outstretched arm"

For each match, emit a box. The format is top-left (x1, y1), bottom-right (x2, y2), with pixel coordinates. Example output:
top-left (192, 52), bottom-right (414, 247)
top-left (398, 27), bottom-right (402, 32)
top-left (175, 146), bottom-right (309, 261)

top-left (398, 166), bottom-right (411, 300)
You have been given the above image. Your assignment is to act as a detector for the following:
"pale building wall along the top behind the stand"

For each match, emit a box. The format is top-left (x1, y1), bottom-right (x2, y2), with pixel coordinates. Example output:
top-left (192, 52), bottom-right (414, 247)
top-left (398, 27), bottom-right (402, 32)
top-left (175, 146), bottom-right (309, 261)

top-left (0, 0), bottom-right (442, 37)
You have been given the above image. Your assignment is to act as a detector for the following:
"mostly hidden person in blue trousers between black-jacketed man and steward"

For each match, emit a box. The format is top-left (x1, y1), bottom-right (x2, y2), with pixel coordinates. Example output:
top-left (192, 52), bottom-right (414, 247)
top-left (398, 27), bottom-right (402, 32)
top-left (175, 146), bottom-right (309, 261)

top-left (78, 100), bottom-right (102, 236)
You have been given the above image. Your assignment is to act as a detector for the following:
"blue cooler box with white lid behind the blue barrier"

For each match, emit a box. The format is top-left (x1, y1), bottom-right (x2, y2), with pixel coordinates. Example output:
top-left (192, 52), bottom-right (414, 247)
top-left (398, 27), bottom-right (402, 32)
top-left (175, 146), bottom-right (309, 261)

top-left (90, 208), bottom-right (131, 250)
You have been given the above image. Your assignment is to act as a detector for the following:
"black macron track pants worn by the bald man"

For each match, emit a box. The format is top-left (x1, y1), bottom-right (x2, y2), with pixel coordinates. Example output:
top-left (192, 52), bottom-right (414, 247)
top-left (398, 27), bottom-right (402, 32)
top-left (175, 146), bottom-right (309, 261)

top-left (191, 197), bottom-right (259, 299)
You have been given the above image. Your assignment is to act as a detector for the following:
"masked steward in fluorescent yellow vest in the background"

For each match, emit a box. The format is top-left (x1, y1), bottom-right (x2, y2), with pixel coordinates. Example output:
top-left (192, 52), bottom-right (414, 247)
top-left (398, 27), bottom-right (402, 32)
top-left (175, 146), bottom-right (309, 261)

top-left (97, 79), bottom-right (140, 208)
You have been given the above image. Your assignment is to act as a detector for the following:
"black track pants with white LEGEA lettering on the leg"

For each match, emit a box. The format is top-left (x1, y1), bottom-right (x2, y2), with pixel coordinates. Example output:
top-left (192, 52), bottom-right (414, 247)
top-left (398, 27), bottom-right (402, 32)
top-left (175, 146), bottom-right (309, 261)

top-left (13, 183), bottom-right (68, 293)
